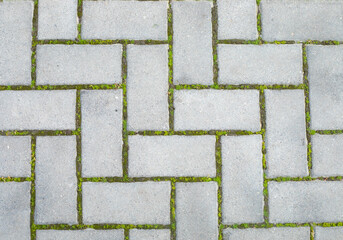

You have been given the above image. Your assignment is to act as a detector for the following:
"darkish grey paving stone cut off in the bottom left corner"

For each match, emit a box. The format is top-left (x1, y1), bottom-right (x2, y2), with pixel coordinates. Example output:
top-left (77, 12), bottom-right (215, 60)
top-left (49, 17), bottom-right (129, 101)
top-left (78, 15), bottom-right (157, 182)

top-left (0, 182), bottom-right (31, 240)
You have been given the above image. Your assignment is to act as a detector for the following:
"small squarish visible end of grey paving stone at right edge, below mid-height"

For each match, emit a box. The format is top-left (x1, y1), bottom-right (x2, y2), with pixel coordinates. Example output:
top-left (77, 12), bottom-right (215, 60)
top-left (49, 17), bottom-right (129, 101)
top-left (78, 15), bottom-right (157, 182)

top-left (311, 134), bottom-right (343, 177)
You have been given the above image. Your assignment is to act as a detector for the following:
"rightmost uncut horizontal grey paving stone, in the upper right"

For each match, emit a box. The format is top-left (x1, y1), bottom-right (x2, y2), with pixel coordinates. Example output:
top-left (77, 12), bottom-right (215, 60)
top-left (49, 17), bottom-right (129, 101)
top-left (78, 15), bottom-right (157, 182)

top-left (218, 44), bottom-right (303, 85)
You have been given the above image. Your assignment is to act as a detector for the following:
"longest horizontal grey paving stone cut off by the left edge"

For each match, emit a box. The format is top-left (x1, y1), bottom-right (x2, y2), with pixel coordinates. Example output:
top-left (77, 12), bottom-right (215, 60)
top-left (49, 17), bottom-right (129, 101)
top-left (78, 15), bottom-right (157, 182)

top-left (0, 90), bottom-right (76, 130)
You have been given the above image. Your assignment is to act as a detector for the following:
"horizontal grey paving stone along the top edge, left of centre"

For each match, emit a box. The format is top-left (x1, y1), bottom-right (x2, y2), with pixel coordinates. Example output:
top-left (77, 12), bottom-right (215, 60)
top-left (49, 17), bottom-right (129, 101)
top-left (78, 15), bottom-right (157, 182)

top-left (81, 1), bottom-right (168, 40)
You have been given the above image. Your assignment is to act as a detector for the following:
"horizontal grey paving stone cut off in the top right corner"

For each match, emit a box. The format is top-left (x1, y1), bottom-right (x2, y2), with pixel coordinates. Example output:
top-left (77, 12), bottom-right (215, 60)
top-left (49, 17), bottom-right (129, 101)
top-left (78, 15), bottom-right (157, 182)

top-left (260, 0), bottom-right (343, 41)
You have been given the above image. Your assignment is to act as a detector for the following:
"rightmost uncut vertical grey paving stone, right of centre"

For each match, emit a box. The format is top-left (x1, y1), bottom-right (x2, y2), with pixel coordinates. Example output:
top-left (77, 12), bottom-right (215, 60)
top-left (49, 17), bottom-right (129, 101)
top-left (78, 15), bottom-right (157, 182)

top-left (265, 90), bottom-right (308, 177)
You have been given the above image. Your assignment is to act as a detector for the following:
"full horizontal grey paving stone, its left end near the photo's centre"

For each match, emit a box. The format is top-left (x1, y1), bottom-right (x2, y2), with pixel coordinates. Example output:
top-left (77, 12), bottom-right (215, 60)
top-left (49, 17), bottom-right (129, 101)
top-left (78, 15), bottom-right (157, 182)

top-left (174, 90), bottom-right (261, 131)
